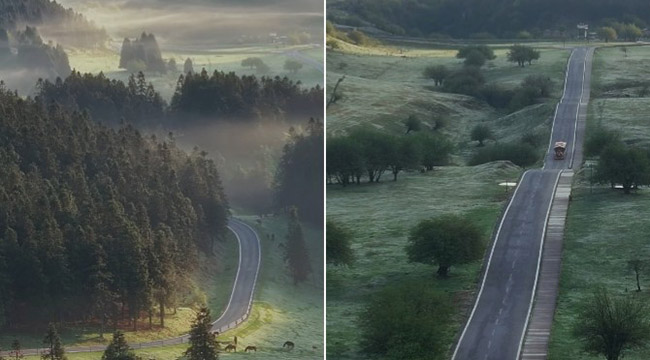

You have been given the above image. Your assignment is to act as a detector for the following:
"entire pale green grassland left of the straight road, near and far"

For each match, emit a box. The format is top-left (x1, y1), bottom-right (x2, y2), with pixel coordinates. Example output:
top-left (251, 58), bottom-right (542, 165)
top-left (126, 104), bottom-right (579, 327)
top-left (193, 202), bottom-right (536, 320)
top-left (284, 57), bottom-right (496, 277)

top-left (327, 43), bottom-right (569, 359)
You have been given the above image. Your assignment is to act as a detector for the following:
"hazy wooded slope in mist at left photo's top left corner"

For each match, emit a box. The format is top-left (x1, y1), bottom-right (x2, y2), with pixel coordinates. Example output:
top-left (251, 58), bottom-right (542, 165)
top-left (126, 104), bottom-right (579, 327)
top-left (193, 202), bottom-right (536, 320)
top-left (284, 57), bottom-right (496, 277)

top-left (0, 0), bottom-right (108, 46)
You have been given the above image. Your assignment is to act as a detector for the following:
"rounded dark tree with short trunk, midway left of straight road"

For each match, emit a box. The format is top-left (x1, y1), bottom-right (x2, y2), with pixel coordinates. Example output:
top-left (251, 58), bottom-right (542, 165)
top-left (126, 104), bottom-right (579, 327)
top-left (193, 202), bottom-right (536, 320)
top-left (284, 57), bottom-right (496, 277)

top-left (406, 215), bottom-right (483, 277)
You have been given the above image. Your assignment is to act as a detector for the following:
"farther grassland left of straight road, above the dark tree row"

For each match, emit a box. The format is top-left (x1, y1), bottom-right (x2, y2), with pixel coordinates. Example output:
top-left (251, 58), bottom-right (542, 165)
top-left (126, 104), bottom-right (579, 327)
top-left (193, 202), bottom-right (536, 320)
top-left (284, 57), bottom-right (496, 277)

top-left (327, 44), bottom-right (569, 162)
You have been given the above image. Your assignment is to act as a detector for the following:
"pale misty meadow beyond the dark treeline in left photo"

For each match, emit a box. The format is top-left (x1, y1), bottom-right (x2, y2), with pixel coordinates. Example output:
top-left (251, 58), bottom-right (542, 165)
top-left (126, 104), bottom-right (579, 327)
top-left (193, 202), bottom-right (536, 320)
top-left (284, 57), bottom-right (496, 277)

top-left (67, 45), bottom-right (323, 101)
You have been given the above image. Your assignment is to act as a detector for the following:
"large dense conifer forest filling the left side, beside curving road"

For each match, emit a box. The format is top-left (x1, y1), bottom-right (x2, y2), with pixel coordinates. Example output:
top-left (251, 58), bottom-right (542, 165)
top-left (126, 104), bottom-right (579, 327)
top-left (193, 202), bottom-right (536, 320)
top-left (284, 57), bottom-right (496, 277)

top-left (0, 89), bottom-right (229, 328)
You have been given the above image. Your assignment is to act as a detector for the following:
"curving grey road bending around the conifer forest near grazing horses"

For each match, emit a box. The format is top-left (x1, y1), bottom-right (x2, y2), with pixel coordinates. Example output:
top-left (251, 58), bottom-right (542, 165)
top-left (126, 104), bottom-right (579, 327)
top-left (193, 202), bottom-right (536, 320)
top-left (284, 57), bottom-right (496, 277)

top-left (0, 218), bottom-right (261, 356)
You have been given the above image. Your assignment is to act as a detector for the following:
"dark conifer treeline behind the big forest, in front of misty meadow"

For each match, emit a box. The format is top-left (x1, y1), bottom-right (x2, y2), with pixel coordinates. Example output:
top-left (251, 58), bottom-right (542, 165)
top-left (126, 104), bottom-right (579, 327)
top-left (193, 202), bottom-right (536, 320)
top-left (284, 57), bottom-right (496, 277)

top-left (37, 70), bottom-right (324, 128)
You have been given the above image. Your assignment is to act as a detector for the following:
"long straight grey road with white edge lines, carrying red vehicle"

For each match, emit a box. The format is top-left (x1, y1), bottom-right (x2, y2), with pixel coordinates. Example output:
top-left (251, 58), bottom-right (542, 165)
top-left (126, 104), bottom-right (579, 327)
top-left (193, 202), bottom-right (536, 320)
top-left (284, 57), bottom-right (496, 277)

top-left (452, 48), bottom-right (589, 360)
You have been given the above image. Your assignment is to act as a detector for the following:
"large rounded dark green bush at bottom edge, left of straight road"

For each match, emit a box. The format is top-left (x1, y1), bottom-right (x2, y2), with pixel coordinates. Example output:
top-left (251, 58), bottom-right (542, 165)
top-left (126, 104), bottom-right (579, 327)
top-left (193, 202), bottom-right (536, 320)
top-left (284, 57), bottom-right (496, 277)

top-left (359, 281), bottom-right (452, 360)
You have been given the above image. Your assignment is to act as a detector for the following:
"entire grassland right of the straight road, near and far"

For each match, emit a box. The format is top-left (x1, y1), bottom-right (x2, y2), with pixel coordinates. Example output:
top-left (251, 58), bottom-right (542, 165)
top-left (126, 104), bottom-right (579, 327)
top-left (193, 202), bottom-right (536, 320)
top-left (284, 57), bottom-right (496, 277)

top-left (549, 46), bottom-right (650, 360)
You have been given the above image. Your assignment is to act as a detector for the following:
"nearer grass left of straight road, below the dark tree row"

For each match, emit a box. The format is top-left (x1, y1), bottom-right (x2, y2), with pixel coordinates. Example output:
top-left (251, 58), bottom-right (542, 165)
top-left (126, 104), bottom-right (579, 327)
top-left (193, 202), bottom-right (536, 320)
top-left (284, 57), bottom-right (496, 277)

top-left (327, 162), bottom-right (521, 359)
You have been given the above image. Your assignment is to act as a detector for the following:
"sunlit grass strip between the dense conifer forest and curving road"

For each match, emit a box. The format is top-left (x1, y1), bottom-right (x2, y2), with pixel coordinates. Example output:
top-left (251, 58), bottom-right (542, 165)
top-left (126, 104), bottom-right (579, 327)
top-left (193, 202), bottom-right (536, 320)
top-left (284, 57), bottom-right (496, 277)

top-left (0, 232), bottom-right (239, 349)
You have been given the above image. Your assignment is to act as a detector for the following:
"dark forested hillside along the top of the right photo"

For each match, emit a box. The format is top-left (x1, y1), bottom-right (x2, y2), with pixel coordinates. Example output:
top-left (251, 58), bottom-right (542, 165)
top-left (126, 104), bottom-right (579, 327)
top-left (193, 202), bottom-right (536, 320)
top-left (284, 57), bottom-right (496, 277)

top-left (328, 0), bottom-right (650, 38)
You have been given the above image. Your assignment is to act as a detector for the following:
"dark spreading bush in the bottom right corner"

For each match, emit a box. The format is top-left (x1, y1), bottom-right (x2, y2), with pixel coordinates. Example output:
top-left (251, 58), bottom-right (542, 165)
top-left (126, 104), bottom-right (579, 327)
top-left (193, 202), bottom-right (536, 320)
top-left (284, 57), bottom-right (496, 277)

top-left (573, 289), bottom-right (650, 360)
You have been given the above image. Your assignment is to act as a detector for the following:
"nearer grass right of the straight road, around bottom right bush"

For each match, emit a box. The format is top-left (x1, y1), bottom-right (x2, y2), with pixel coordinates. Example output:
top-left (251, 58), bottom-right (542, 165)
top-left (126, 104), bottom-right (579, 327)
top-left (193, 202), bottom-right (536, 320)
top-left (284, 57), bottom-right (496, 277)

top-left (549, 172), bottom-right (650, 360)
